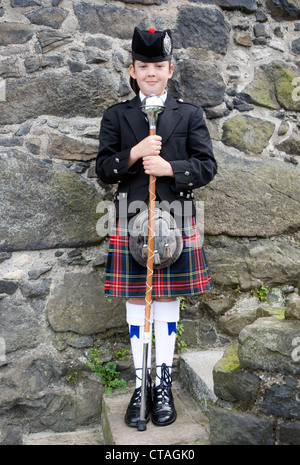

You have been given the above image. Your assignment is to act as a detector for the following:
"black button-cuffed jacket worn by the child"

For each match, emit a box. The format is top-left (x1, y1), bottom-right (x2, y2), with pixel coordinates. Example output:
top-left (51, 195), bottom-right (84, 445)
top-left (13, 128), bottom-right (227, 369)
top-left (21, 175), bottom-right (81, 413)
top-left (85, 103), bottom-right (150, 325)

top-left (96, 96), bottom-right (217, 216)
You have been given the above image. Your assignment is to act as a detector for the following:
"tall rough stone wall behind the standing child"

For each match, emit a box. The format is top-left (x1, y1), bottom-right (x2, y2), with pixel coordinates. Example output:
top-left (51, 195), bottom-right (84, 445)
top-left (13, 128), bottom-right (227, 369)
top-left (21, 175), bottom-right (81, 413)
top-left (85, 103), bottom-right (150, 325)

top-left (0, 0), bottom-right (300, 444)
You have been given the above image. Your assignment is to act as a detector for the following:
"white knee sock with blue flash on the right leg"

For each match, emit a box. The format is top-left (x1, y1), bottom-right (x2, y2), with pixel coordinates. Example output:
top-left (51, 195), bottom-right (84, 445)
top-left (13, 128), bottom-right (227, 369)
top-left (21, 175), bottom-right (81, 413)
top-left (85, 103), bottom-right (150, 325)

top-left (153, 299), bottom-right (180, 386)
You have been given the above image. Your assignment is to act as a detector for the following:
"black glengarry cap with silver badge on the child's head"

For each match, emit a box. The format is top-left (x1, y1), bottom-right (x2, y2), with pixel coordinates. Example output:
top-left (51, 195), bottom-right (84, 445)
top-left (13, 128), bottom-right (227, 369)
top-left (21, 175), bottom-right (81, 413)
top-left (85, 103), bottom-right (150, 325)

top-left (132, 27), bottom-right (173, 63)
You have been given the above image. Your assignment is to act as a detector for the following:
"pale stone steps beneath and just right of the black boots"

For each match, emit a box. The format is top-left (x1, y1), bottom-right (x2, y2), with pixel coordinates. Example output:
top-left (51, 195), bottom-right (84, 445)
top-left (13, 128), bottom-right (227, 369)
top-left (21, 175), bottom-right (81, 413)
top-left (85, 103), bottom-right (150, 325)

top-left (102, 350), bottom-right (223, 445)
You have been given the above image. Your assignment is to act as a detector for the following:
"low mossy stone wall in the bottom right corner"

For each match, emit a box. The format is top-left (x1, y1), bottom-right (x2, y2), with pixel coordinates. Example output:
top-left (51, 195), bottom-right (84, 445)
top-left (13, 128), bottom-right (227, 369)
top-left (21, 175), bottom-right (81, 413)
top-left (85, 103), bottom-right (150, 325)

top-left (210, 294), bottom-right (300, 445)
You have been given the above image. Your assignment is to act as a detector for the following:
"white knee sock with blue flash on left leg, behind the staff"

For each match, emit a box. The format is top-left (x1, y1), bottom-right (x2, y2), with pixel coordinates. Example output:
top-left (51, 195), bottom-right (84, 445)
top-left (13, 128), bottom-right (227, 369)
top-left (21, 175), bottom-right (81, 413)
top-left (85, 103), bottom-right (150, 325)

top-left (126, 302), bottom-right (153, 388)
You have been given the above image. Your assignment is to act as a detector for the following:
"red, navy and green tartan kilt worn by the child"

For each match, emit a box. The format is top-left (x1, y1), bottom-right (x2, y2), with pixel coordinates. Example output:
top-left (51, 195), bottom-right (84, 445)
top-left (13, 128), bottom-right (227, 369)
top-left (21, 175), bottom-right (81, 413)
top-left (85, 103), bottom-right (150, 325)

top-left (105, 217), bottom-right (212, 298)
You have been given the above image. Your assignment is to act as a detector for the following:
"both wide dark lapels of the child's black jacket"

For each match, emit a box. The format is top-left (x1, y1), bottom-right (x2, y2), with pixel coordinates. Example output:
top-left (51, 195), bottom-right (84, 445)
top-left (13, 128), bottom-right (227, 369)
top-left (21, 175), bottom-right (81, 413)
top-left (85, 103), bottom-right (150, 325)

top-left (125, 96), bottom-right (182, 145)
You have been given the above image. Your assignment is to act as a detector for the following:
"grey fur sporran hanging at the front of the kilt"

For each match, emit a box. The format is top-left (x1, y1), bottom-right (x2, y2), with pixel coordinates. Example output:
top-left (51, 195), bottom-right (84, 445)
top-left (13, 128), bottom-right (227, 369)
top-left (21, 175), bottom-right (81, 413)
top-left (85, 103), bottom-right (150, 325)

top-left (129, 208), bottom-right (183, 268)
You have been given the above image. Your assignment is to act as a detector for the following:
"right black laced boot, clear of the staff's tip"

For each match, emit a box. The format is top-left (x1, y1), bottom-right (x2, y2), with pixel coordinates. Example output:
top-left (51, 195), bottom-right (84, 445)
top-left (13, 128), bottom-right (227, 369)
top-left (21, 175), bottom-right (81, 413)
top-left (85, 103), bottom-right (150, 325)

top-left (152, 363), bottom-right (177, 426)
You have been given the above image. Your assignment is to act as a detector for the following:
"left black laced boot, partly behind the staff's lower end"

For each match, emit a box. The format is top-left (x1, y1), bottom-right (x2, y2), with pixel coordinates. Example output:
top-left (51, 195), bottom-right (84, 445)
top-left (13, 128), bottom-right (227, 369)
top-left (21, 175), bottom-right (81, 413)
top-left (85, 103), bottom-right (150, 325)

top-left (125, 372), bottom-right (152, 427)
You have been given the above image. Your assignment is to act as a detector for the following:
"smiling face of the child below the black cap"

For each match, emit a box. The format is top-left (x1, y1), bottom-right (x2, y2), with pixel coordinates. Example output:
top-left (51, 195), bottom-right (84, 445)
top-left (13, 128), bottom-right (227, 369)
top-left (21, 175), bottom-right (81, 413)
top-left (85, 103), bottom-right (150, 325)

top-left (129, 60), bottom-right (174, 97)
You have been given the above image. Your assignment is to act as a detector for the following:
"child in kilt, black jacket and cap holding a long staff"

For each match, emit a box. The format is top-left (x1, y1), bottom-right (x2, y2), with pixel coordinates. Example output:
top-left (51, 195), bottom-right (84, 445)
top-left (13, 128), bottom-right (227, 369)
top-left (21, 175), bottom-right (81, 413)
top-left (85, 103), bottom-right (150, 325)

top-left (96, 28), bottom-right (217, 426)
